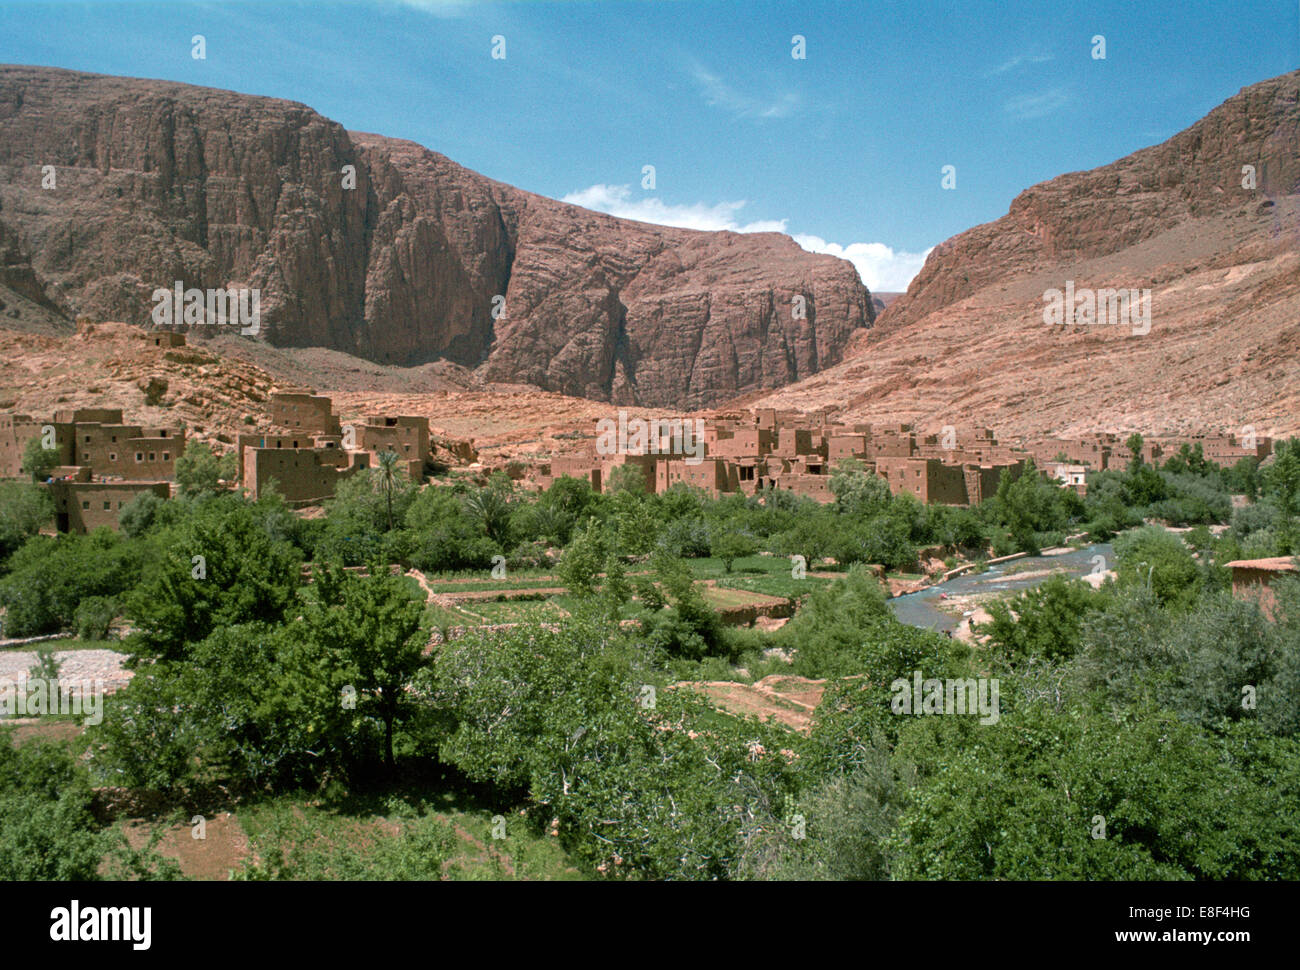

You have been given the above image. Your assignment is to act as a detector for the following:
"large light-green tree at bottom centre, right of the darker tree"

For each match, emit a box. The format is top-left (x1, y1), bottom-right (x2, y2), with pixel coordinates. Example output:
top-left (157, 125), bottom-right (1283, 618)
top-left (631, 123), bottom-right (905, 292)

top-left (433, 614), bottom-right (798, 879)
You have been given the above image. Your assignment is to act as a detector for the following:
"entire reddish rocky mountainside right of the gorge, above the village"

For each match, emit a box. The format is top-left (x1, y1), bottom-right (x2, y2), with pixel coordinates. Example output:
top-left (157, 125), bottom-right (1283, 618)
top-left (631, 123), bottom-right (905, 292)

top-left (744, 72), bottom-right (1300, 437)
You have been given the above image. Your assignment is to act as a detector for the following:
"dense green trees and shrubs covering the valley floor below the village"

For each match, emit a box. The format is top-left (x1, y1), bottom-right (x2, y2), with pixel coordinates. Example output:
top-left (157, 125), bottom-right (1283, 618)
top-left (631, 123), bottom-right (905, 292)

top-left (0, 431), bottom-right (1300, 879)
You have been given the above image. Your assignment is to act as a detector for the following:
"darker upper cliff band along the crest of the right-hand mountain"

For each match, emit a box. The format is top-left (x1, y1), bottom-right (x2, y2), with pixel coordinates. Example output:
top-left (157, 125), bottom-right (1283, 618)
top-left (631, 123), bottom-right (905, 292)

top-left (885, 72), bottom-right (1300, 326)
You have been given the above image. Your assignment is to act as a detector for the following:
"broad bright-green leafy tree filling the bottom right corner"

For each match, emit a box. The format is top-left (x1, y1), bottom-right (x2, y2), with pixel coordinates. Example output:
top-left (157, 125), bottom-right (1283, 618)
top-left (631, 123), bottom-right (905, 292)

top-left (889, 702), bottom-right (1300, 880)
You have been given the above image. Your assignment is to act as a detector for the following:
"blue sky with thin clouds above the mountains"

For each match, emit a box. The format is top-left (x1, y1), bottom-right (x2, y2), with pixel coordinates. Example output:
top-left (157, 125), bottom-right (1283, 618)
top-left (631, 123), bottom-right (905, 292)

top-left (0, 0), bottom-right (1300, 290)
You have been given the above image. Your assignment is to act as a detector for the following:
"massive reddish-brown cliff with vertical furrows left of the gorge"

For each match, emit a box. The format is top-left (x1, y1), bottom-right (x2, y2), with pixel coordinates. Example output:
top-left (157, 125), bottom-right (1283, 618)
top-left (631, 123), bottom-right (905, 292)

top-left (0, 66), bottom-right (875, 407)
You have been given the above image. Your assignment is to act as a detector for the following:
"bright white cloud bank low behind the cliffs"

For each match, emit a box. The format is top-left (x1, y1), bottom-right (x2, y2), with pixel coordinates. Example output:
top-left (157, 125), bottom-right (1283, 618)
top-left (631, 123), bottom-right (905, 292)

top-left (562, 185), bottom-right (933, 293)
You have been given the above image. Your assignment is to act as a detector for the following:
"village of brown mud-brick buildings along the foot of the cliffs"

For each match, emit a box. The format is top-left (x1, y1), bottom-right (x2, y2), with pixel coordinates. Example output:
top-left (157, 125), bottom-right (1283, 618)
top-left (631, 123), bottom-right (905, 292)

top-left (0, 330), bottom-right (1273, 533)
